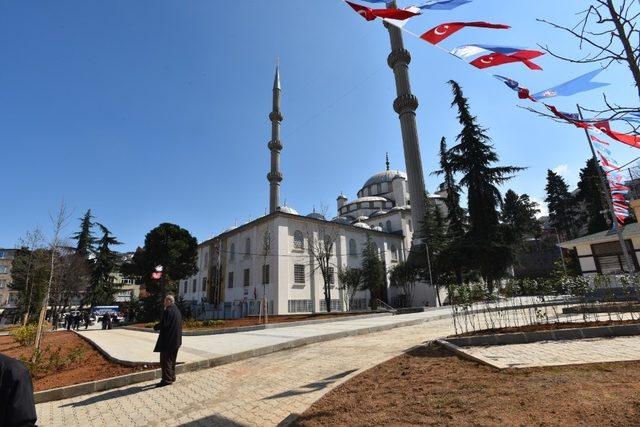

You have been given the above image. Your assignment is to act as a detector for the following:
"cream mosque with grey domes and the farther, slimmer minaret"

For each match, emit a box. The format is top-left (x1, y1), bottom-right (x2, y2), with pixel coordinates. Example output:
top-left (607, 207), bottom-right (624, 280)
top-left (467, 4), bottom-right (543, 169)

top-left (179, 68), bottom-right (446, 318)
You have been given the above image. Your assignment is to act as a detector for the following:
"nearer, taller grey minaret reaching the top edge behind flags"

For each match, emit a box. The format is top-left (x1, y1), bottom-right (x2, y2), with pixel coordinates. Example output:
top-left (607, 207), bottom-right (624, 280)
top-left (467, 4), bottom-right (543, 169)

top-left (384, 0), bottom-right (425, 246)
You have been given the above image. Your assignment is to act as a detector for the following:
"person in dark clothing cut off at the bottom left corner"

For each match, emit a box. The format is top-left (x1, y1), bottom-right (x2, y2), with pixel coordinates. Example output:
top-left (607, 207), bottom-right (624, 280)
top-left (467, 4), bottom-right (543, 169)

top-left (0, 354), bottom-right (38, 427)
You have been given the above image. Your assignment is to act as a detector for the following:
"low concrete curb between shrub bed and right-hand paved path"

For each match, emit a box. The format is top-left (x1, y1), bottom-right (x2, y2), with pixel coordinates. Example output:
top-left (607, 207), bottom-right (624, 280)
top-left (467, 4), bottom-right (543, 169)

top-left (447, 323), bottom-right (640, 347)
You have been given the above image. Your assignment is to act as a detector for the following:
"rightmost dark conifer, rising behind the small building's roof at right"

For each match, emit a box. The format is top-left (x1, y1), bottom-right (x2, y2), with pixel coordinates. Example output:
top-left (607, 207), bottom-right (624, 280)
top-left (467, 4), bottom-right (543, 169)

top-left (578, 157), bottom-right (609, 234)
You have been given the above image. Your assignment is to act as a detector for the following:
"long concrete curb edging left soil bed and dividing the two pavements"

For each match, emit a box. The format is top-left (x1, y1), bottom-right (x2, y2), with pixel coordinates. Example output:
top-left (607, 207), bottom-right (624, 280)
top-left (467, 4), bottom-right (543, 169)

top-left (34, 313), bottom-right (451, 403)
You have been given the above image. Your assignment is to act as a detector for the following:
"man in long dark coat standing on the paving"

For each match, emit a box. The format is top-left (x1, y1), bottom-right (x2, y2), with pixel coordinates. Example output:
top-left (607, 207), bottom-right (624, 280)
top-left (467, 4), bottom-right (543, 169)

top-left (153, 295), bottom-right (182, 387)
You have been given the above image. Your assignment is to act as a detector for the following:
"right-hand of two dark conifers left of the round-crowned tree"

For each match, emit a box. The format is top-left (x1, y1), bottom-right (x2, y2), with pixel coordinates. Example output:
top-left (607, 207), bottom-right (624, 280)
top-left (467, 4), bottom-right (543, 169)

top-left (89, 223), bottom-right (121, 307)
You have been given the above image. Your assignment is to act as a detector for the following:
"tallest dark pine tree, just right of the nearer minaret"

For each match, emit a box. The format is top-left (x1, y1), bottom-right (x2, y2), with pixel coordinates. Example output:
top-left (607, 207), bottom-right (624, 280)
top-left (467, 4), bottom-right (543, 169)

top-left (449, 80), bottom-right (523, 292)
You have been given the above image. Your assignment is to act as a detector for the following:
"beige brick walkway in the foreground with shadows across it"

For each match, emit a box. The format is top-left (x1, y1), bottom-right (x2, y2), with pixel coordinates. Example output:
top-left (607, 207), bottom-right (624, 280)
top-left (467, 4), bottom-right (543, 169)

top-left (37, 319), bottom-right (453, 427)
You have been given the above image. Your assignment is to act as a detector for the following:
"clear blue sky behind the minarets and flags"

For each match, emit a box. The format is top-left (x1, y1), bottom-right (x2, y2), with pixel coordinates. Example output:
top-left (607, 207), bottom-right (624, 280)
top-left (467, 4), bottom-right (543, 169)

top-left (0, 0), bottom-right (640, 250)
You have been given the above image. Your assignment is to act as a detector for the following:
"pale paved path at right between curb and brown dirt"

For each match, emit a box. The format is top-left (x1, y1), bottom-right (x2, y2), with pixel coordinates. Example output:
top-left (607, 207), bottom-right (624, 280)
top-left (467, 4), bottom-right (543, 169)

top-left (462, 336), bottom-right (640, 368)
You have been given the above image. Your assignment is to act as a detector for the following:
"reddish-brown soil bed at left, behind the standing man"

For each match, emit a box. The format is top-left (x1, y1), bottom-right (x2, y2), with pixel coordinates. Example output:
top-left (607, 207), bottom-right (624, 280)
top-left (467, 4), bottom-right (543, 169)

top-left (0, 331), bottom-right (155, 391)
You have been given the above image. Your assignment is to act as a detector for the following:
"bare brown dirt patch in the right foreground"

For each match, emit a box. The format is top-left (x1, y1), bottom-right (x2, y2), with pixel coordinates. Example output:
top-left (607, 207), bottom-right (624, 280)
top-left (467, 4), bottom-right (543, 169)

top-left (295, 347), bottom-right (640, 427)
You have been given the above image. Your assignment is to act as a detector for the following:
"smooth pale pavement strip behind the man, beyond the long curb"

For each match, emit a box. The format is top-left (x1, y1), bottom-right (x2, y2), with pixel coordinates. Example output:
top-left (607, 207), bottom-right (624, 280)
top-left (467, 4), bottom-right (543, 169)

top-left (80, 308), bottom-right (451, 363)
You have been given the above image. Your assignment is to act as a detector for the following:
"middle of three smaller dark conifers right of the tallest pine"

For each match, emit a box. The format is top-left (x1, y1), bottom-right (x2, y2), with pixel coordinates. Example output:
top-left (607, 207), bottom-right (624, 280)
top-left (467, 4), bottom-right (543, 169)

top-left (544, 170), bottom-right (578, 240)
